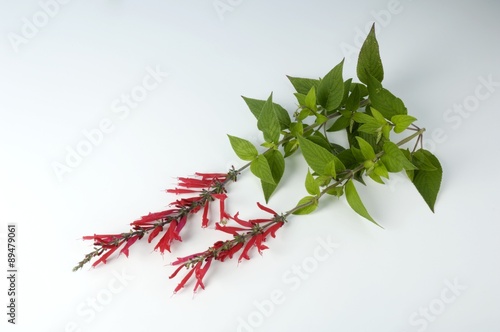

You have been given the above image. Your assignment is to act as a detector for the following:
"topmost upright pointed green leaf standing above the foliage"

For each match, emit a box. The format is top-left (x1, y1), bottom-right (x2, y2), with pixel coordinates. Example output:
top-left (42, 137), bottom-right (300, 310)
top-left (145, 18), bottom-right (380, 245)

top-left (356, 24), bottom-right (384, 84)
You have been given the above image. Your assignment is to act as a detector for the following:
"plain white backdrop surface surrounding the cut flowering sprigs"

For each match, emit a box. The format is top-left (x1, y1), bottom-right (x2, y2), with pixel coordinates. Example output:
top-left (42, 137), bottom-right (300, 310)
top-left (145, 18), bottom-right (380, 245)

top-left (0, 0), bottom-right (500, 332)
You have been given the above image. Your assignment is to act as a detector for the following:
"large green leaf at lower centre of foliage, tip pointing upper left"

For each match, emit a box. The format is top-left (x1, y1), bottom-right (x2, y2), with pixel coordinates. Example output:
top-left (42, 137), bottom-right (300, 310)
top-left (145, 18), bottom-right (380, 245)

top-left (297, 136), bottom-right (345, 175)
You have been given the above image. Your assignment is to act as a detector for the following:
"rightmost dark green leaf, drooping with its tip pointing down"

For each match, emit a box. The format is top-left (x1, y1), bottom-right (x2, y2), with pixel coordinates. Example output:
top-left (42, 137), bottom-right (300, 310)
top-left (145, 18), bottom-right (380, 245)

top-left (413, 149), bottom-right (443, 212)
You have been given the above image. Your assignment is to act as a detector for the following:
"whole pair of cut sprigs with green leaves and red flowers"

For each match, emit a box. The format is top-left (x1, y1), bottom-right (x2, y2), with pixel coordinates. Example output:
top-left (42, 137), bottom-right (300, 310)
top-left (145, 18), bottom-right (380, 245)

top-left (74, 26), bottom-right (443, 292)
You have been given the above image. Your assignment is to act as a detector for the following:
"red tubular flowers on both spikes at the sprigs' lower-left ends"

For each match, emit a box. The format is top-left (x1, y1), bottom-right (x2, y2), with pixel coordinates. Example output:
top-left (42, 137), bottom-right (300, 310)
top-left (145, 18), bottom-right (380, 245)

top-left (75, 171), bottom-right (285, 293)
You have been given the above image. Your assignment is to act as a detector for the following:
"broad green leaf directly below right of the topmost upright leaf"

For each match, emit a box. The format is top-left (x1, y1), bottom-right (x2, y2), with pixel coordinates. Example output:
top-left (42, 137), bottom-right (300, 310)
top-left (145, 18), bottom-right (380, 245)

top-left (368, 76), bottom-right (408, 119)
